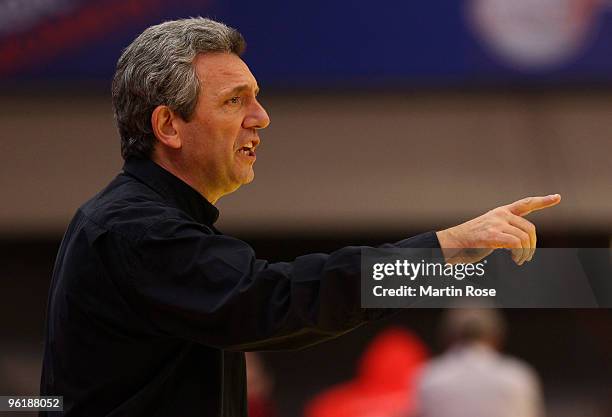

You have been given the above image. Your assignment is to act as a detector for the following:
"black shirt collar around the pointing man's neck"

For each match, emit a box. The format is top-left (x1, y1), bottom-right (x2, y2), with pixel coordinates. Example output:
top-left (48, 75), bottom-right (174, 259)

top-left (123, 158), bottom-right (219, 226)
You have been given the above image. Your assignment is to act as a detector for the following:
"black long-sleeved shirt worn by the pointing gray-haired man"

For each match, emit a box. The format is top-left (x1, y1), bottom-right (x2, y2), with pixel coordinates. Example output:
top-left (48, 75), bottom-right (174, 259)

top-left (41, 160), bottom-right (438, 417)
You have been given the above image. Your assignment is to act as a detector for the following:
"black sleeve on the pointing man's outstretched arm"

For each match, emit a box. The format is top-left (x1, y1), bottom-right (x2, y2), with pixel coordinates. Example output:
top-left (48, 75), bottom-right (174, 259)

top-left (116, 219), bottom-right (438, 351)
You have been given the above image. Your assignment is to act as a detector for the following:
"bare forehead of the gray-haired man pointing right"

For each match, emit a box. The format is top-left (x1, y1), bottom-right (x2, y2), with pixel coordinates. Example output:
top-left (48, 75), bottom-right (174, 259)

top-left (194, 53), bottom-right (257, 94)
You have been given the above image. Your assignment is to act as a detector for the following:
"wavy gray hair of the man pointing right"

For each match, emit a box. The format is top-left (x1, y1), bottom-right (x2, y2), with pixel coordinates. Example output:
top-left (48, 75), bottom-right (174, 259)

top-left (112, 17), bottom-right (246, 159)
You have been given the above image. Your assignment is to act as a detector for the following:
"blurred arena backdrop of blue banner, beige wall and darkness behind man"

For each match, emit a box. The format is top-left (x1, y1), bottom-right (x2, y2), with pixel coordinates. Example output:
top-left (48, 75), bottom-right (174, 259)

top-left (0, 0), bottom-right (612, 417)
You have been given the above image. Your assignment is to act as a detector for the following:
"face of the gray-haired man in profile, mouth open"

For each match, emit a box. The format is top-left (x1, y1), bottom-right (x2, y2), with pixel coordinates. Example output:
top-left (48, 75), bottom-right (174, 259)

top-left (180, 53), bottom-right (270, 203)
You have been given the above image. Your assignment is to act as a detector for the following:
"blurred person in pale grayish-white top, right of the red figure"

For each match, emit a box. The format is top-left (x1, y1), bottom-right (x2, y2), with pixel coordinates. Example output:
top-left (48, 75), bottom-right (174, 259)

top-left (414, 308), bottom-right (544, 417)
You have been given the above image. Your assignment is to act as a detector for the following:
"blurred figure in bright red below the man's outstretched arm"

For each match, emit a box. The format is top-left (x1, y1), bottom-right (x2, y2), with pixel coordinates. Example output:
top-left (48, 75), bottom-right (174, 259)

top-left (305, 327), bottom-right (429, 417)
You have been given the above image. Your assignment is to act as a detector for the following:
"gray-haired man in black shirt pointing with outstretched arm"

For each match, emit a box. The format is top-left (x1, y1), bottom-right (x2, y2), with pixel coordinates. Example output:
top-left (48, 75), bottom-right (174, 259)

top-left (41, 18), bottom-right (559, 417)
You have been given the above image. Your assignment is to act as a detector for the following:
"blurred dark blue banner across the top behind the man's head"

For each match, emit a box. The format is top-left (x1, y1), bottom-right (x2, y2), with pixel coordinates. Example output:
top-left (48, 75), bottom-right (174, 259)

top-left (0, 0), bottom-right (612, 88)
